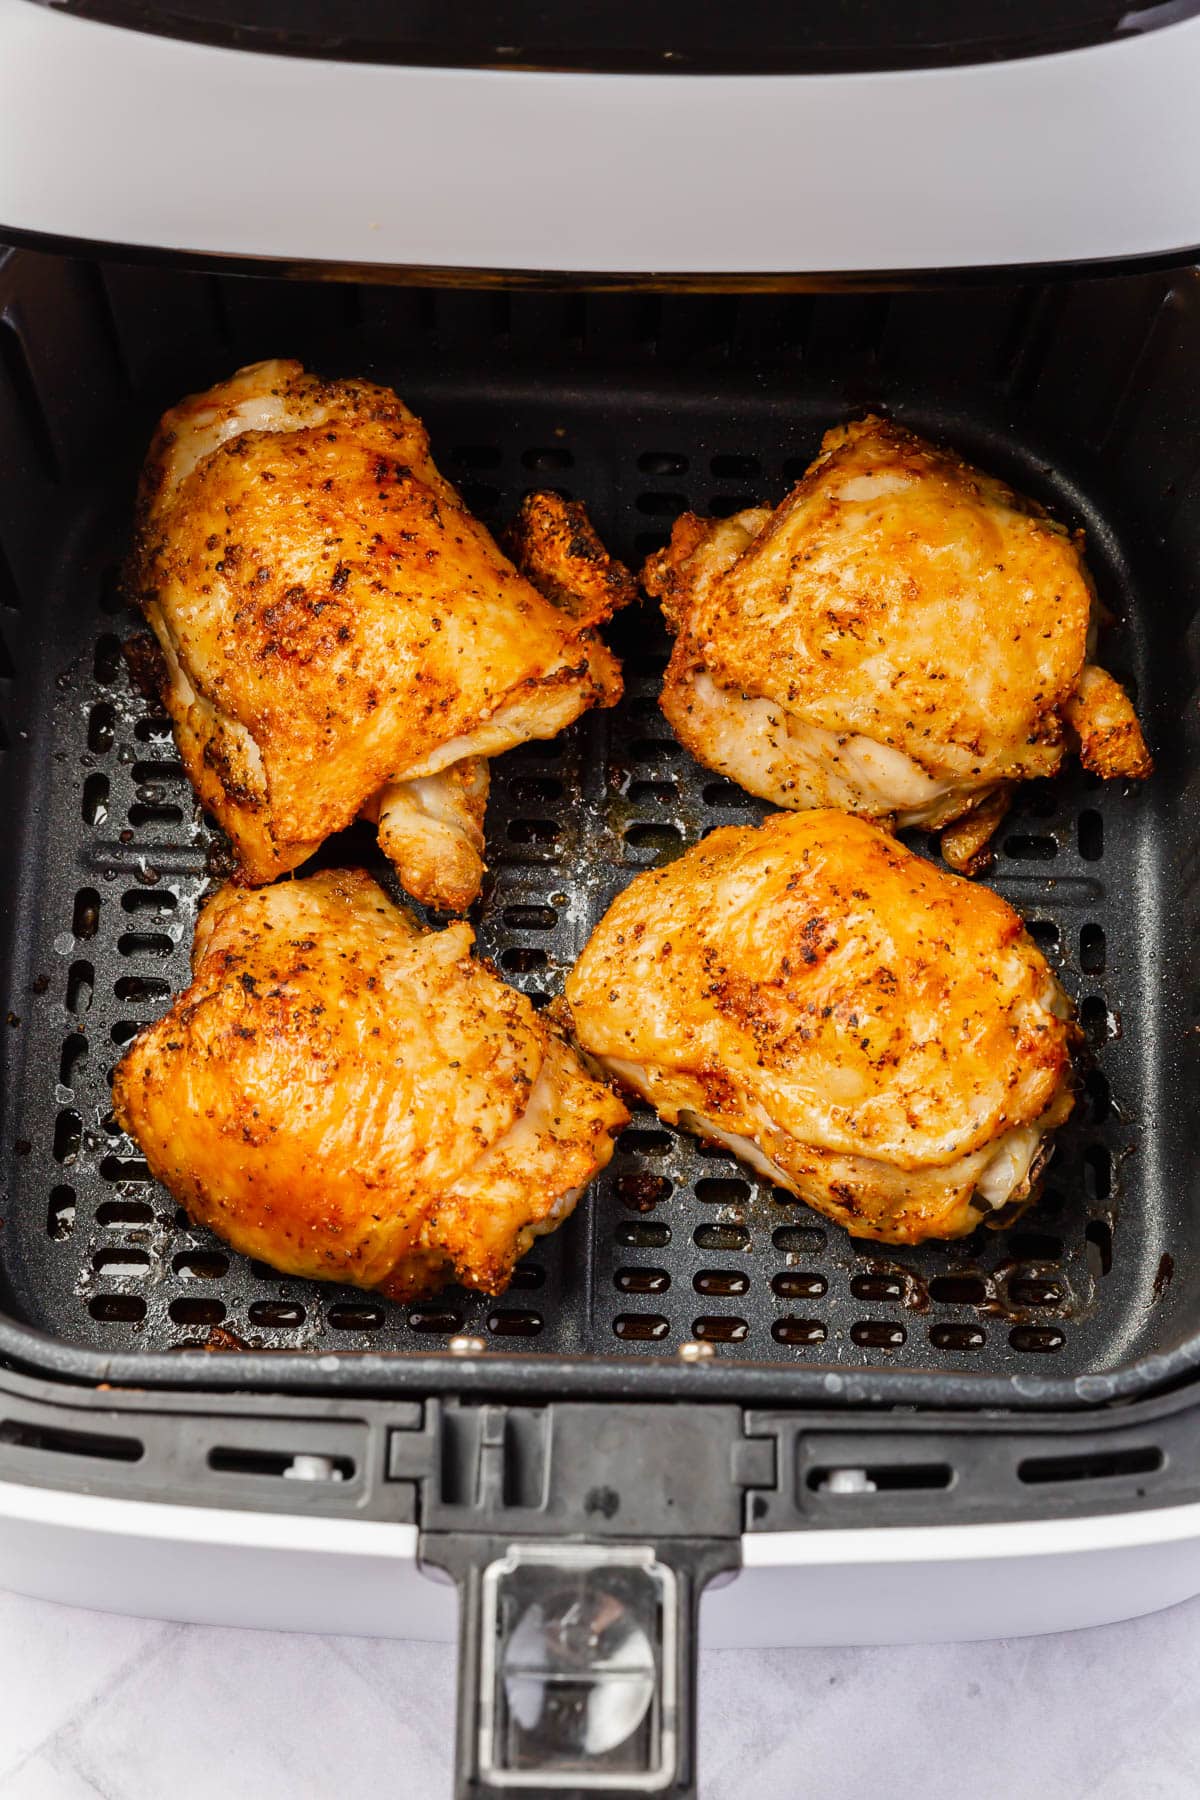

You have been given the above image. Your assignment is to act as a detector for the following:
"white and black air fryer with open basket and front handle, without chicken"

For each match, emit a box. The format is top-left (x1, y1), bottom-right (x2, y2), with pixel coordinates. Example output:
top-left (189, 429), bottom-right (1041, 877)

top-left (0, 0), bottom-right (1200, 1796)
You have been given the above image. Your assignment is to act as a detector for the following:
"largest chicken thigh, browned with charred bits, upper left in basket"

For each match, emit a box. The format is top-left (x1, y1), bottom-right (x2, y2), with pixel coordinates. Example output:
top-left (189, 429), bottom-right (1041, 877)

top-left (130, 362), bottom-right (633, 911)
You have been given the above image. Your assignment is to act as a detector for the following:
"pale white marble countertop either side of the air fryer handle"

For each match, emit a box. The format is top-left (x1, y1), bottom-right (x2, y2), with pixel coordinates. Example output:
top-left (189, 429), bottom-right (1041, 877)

top-left (0, 1593), bottom-right (1200, 1800)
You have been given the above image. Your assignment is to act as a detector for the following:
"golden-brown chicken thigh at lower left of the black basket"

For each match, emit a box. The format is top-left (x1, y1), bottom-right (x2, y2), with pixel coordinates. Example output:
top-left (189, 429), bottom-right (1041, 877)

top-left (113, 871), bottom-right (628, 1300)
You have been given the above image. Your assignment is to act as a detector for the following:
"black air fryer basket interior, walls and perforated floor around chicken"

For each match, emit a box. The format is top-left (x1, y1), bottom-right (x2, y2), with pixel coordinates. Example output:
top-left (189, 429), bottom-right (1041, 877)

top-left (0, 252), bottom-right (1200, 1399)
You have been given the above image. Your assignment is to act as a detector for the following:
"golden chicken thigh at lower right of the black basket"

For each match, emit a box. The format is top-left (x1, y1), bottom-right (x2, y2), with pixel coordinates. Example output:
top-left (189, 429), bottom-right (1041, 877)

top-left (567, 810), bottom-right (1076, 1244)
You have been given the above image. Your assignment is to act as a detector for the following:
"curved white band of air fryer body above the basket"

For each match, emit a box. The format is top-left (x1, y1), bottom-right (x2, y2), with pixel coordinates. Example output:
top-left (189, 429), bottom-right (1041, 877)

top-left (0, 0), bottom-right (1200, 277)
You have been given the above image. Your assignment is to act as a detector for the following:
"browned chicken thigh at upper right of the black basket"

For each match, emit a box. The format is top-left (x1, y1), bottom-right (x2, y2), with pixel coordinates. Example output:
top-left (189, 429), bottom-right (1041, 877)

top-left (642, 418), bottom-right (1151, 871)
